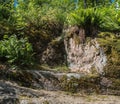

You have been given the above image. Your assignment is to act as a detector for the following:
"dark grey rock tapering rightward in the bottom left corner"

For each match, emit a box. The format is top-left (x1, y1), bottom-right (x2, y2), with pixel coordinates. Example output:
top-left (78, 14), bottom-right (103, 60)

top-left (0, 80), bottom-right (42, 104)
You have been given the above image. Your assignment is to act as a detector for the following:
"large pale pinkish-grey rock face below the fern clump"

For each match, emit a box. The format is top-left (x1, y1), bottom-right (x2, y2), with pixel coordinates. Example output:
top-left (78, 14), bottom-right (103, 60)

top-left (64, 28), bottom-right (107, 73)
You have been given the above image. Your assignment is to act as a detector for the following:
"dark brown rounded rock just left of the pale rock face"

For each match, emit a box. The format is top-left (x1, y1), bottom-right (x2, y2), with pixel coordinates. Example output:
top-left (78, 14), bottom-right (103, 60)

top-left (41, 37), bottom-right (65, 66)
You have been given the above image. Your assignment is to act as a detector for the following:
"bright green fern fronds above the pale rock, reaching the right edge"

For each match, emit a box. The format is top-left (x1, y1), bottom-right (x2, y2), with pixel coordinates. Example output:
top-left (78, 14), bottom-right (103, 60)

top-left (67, 6), bottom-right (120, 31)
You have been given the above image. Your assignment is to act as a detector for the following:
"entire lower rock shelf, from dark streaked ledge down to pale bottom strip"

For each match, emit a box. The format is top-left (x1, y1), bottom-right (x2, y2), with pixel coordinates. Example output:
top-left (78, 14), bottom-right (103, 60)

top-left (0, 69), bottom-right (120, 104)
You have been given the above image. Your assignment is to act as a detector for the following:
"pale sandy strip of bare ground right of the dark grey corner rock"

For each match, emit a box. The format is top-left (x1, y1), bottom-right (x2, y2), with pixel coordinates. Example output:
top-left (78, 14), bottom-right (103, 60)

top-left (20, 90), bottom-right (120, 104)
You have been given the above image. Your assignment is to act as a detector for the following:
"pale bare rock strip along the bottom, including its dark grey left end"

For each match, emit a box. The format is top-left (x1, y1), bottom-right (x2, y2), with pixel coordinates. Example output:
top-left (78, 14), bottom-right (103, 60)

top-left (0, 81), bottom-right (120, 104)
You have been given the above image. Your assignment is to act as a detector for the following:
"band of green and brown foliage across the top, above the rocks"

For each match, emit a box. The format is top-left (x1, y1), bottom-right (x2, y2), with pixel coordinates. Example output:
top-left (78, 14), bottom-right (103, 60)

top-left (0, 0), bottom-right (120, 66)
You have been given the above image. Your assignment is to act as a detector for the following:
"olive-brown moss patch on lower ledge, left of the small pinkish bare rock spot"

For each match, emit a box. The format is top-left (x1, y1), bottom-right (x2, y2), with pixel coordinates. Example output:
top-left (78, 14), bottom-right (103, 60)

top-left (60, 75), bottom-right (100, 93)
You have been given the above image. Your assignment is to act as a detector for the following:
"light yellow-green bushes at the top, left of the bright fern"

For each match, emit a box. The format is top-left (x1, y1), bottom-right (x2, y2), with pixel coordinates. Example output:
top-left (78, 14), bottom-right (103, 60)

top-left (14, 0), bottom-right (70, 27)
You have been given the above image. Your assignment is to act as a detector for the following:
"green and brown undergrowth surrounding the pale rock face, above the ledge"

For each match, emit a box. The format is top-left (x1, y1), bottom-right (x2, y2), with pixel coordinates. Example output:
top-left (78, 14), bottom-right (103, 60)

top-left (0, 0), bottom-right (120, 75)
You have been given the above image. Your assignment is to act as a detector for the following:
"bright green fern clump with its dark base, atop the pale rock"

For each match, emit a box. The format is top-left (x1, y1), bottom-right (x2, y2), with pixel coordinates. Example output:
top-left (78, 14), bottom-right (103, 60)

top-left (67, 8), bottom-right (103, 36)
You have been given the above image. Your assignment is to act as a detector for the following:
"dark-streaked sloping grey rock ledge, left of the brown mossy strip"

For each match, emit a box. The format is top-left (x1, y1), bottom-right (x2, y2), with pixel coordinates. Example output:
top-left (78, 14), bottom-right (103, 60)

top-left (0, 69), bottom-right (84, 90)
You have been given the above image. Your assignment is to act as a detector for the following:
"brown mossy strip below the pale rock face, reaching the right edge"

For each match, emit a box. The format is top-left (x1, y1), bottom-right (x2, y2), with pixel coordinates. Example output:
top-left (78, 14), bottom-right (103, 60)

top-left (60, 74), bottom-right (120, 95)
